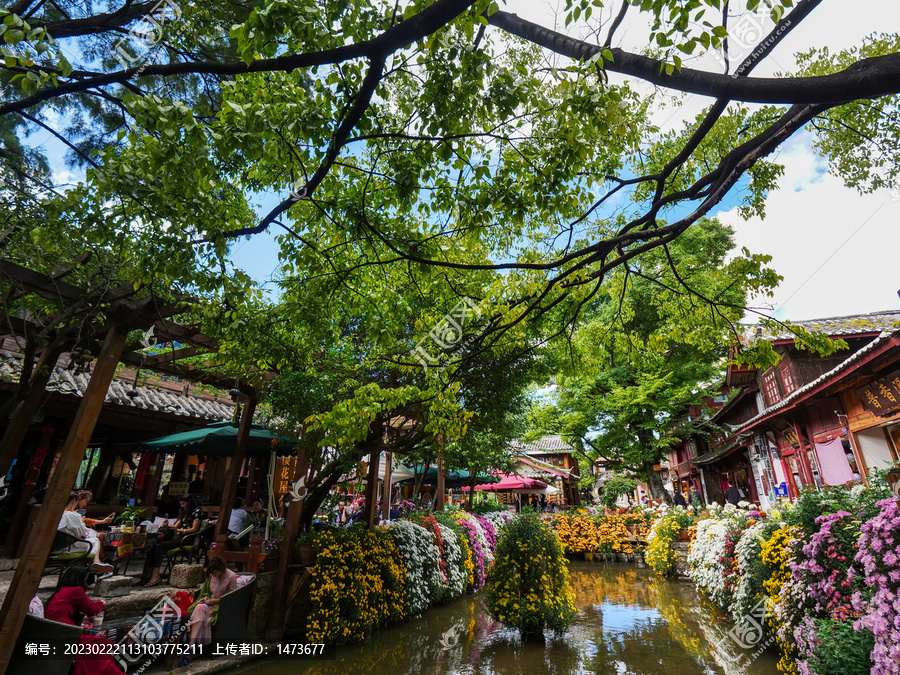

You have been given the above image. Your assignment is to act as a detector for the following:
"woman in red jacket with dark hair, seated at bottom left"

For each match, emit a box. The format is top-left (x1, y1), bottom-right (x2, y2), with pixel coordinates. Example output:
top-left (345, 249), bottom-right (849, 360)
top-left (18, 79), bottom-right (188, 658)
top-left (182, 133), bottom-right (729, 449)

top-left (44, 565), bottom-right (124, 675)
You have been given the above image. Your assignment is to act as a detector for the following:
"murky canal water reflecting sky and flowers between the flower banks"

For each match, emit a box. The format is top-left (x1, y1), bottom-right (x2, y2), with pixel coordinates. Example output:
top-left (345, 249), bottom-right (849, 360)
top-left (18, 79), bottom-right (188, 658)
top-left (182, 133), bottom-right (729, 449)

top-left (233, 563), bottom-right (777, 675)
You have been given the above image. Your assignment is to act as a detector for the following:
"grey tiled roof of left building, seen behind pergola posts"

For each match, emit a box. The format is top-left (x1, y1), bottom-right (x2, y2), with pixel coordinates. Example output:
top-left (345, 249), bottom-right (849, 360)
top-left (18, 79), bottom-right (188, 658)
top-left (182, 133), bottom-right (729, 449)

top-left (0, 352), bottom-right (234, 422)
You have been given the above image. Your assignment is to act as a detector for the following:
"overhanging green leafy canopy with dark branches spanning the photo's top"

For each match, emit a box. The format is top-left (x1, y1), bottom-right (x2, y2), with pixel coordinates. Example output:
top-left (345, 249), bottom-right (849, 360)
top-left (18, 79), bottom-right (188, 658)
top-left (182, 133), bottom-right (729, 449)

top-left (0, 0), bottom-right (900, 360)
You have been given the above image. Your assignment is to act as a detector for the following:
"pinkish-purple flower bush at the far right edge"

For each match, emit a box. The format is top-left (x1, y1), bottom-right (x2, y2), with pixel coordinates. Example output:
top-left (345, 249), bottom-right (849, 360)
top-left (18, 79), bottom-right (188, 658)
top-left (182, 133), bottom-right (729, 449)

top-left (853, 498), bottom-right (900, 675)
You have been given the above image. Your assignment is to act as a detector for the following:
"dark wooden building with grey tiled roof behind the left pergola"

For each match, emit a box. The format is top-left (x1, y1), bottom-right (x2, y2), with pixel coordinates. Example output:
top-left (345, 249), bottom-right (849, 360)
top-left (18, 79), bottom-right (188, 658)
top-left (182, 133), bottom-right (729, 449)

top-left (0, 337), bottom-right (234, 557)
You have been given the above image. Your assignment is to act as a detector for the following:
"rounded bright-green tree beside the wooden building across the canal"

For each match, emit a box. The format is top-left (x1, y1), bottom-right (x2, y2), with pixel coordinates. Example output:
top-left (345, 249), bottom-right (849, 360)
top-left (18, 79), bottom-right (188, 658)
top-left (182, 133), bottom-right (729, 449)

top-left (530, 219), bottom-right (779, 498)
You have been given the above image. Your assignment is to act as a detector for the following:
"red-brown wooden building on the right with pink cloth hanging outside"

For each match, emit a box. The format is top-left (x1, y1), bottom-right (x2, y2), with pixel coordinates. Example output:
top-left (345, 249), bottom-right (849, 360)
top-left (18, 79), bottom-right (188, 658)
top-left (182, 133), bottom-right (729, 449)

top-left (676, 311), bottom-right (900, 505)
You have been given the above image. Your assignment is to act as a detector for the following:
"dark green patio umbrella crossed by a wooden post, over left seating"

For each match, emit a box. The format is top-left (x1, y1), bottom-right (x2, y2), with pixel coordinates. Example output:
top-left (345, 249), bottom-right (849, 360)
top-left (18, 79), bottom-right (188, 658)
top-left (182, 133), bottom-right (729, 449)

top-left (140, 422), bottom-right (297, 457)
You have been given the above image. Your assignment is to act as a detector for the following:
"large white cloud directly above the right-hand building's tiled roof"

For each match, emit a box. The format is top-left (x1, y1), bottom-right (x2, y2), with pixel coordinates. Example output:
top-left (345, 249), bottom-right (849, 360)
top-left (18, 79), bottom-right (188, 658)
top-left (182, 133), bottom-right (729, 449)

top-left (719, 136), bottom-right (900, 320)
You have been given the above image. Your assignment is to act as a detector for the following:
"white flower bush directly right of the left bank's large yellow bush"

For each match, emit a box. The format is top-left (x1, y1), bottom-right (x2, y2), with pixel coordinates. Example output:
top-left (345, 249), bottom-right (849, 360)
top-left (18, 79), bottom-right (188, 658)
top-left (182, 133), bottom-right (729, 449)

top-left (388, 520), bottom-right (446, 616)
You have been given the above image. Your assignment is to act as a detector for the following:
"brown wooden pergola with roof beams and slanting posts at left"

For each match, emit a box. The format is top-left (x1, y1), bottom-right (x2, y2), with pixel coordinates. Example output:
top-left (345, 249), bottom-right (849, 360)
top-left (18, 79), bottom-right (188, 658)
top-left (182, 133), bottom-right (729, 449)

top-left (0, 254), bottom-right (284, 674)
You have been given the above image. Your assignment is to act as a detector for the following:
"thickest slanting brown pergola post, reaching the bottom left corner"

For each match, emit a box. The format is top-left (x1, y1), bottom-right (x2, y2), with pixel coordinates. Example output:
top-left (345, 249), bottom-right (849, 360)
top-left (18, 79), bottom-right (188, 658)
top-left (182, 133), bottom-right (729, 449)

top-left (0, 325), bottom-right (128, 675)
